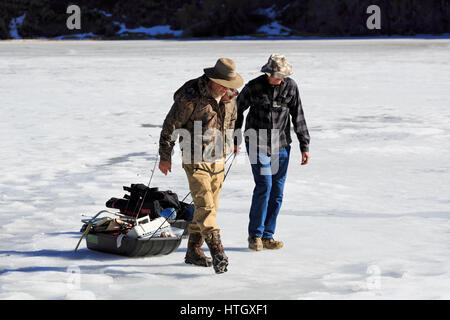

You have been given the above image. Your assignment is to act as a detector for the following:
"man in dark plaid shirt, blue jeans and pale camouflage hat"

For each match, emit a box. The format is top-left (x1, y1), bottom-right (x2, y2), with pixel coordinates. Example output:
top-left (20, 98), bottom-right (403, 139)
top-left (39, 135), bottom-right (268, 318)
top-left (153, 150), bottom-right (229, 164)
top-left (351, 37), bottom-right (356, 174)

top-left (235, 54), bottom-right (310, 251)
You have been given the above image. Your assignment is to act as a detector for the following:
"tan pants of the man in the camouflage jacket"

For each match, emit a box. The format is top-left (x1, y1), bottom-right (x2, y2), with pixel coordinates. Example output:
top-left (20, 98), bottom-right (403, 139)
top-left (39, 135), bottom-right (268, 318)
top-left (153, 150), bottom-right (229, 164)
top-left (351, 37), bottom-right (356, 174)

top-left (183, 162), bottom-right (225, 237)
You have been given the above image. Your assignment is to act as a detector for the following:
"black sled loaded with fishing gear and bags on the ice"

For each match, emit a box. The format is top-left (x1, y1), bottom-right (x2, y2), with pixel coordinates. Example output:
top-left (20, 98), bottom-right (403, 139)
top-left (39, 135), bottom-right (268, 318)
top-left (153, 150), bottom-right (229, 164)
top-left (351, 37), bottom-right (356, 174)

top-left (75, 184), bottom-right (194, 257)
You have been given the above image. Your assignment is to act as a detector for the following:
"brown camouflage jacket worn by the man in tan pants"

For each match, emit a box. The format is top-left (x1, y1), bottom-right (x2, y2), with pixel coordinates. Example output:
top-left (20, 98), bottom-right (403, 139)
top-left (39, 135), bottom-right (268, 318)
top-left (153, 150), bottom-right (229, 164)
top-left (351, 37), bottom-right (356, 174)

top-left (159, 75), bottom-right (238, 163)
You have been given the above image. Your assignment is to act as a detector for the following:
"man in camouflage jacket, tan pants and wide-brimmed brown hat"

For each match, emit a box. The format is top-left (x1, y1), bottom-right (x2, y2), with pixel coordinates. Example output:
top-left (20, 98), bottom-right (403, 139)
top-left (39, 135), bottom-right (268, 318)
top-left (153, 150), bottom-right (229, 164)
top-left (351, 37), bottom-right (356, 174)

top-left (159, 58), bottom-right (243, 273)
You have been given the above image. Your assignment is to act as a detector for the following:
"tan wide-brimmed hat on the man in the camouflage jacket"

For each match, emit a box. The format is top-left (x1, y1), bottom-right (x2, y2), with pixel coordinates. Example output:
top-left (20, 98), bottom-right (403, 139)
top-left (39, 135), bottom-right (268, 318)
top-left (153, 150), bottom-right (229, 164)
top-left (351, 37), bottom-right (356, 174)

top-left (203, 58), bottom-right (244, 89)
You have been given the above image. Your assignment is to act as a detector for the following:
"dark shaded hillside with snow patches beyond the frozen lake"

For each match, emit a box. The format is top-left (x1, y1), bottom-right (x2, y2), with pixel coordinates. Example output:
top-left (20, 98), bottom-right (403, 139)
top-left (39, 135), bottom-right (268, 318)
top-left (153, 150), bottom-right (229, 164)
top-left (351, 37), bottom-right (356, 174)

top-left (0, 0), bottom-right (450, 40)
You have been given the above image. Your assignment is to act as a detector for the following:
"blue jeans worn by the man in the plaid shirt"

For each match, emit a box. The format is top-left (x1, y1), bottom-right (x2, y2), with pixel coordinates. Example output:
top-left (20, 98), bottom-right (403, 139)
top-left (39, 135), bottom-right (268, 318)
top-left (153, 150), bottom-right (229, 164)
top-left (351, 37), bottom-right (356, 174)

top-left (246, 144), bottom-right (291, 239)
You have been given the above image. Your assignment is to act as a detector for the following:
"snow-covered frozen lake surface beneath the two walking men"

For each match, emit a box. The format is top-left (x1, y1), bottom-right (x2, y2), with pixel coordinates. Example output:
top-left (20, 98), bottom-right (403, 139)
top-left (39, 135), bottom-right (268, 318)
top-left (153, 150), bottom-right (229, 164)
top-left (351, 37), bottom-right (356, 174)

top-left (0, 39), bottom-right (450, 299)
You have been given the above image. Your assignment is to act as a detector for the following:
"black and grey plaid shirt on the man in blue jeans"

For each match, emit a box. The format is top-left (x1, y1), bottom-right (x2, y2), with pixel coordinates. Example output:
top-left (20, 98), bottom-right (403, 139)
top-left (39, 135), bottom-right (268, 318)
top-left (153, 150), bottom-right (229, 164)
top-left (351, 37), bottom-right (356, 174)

top-left (235, 74), bottom-right (310, 153)
